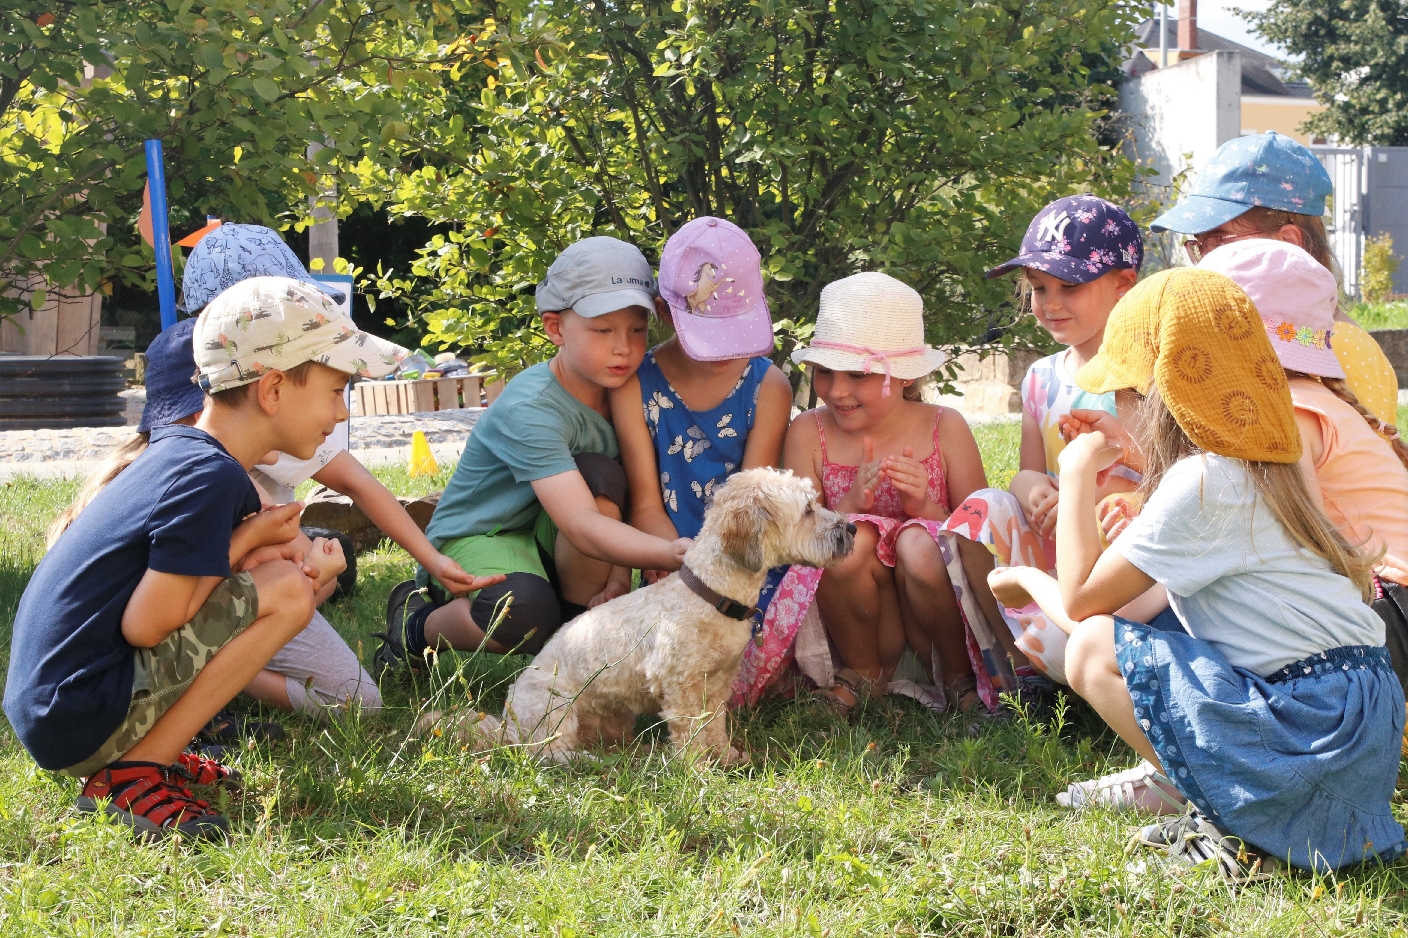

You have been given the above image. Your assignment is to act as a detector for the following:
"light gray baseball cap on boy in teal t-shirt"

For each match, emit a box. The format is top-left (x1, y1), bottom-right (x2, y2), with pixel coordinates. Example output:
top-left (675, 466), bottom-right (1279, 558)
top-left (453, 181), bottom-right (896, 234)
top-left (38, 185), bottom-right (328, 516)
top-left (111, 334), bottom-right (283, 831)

top-left (536, 237), bottom-right (659, 318)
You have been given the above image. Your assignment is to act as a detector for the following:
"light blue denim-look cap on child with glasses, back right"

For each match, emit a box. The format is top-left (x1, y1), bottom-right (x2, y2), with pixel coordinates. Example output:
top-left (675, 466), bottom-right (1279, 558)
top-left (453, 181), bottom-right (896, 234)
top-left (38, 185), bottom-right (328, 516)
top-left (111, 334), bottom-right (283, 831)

top-left (1149, 131), bottom-right (1335, 235)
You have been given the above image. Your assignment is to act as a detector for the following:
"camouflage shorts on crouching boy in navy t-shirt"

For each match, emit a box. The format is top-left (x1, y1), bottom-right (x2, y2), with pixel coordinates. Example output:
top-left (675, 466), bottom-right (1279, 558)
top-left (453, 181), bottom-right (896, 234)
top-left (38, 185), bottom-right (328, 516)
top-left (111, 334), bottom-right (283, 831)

top-left (59, 573), bottom-right (259, 777)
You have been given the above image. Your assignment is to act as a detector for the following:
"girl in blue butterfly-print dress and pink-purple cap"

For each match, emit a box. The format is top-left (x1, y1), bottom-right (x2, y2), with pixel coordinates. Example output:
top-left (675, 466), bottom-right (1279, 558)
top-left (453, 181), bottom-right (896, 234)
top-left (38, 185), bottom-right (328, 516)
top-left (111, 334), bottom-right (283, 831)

top-left (611, 217), bottom-right (791, 703)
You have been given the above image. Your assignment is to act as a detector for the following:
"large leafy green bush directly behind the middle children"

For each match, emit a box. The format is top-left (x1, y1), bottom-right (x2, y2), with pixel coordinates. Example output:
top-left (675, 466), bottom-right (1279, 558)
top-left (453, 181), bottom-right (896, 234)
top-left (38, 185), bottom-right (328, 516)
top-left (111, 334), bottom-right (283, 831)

top-left (356, 0), bottom-right (1140, 369)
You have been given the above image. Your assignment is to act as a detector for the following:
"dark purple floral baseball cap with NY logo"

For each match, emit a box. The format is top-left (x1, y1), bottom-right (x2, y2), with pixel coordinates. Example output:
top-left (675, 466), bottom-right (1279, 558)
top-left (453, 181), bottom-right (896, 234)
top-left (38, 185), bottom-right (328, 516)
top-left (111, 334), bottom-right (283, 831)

top-left (987, 196), bottom-right (1143, 283)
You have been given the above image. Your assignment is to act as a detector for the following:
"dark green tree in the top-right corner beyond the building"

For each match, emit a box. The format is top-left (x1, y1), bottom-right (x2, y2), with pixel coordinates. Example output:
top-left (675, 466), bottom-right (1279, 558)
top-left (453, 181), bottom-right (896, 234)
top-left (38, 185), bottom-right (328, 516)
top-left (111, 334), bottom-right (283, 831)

top-left (1245, 0), bottom-right (1408, 146)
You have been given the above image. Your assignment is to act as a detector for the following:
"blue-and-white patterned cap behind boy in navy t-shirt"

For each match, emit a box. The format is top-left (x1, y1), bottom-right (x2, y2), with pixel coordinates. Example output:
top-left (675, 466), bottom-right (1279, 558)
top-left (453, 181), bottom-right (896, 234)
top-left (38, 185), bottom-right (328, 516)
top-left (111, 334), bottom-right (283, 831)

top-left (180, 225), bottom-right (346, 313)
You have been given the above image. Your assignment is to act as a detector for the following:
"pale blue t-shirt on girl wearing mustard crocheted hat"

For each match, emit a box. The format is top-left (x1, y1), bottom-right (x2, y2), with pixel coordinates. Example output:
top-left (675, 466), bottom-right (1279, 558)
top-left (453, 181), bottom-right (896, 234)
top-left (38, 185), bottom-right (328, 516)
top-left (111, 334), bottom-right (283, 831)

top-left (1112, 454), bottom-right (1384, 677)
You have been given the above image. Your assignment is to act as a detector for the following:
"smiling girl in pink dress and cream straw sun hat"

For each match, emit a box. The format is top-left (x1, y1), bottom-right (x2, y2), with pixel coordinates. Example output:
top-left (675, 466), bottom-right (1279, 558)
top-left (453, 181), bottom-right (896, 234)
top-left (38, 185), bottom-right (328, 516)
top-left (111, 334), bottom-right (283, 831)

top-left (779, 273), bottom-right (1025, 708)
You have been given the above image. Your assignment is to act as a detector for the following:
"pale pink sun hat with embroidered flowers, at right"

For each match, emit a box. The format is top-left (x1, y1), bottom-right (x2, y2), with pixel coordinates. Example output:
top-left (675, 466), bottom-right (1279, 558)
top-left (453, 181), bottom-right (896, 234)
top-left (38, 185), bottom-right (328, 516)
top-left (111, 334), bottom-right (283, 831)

top-left (1198, 238), bottom-right (1345, 377)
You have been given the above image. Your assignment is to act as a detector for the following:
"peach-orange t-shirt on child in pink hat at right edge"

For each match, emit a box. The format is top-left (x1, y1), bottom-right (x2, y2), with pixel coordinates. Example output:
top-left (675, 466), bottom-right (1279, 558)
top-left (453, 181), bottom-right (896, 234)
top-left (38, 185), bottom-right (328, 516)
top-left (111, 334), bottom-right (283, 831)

top-left (1291, 379), bottom-right (1408, 586)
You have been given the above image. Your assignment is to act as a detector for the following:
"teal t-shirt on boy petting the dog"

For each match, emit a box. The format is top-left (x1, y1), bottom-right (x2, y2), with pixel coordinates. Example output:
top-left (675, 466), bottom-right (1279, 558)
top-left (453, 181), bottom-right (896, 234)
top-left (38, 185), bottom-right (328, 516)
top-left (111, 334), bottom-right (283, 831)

top-left (425, 362), bottom-right (621, 549)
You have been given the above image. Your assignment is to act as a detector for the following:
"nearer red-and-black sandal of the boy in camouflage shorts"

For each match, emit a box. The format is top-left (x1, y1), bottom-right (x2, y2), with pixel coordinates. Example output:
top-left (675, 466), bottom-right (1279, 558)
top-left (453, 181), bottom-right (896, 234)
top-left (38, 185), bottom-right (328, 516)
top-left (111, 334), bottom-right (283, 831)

top-left (77, 762), bottom-right (230, 841)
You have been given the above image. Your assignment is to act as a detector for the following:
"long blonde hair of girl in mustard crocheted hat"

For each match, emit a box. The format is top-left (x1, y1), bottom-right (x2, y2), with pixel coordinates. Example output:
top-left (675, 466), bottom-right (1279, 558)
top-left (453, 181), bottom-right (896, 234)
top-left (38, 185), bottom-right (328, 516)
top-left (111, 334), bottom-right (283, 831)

top-left (1136, 386), bottom-right (1383, 603)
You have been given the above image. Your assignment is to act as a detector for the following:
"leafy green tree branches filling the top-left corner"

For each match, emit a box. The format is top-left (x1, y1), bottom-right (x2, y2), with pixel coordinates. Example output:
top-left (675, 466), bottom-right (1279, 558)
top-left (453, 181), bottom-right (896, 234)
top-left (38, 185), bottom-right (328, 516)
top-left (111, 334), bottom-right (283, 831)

top-left (0, 0), bottom-right (480, 315)
